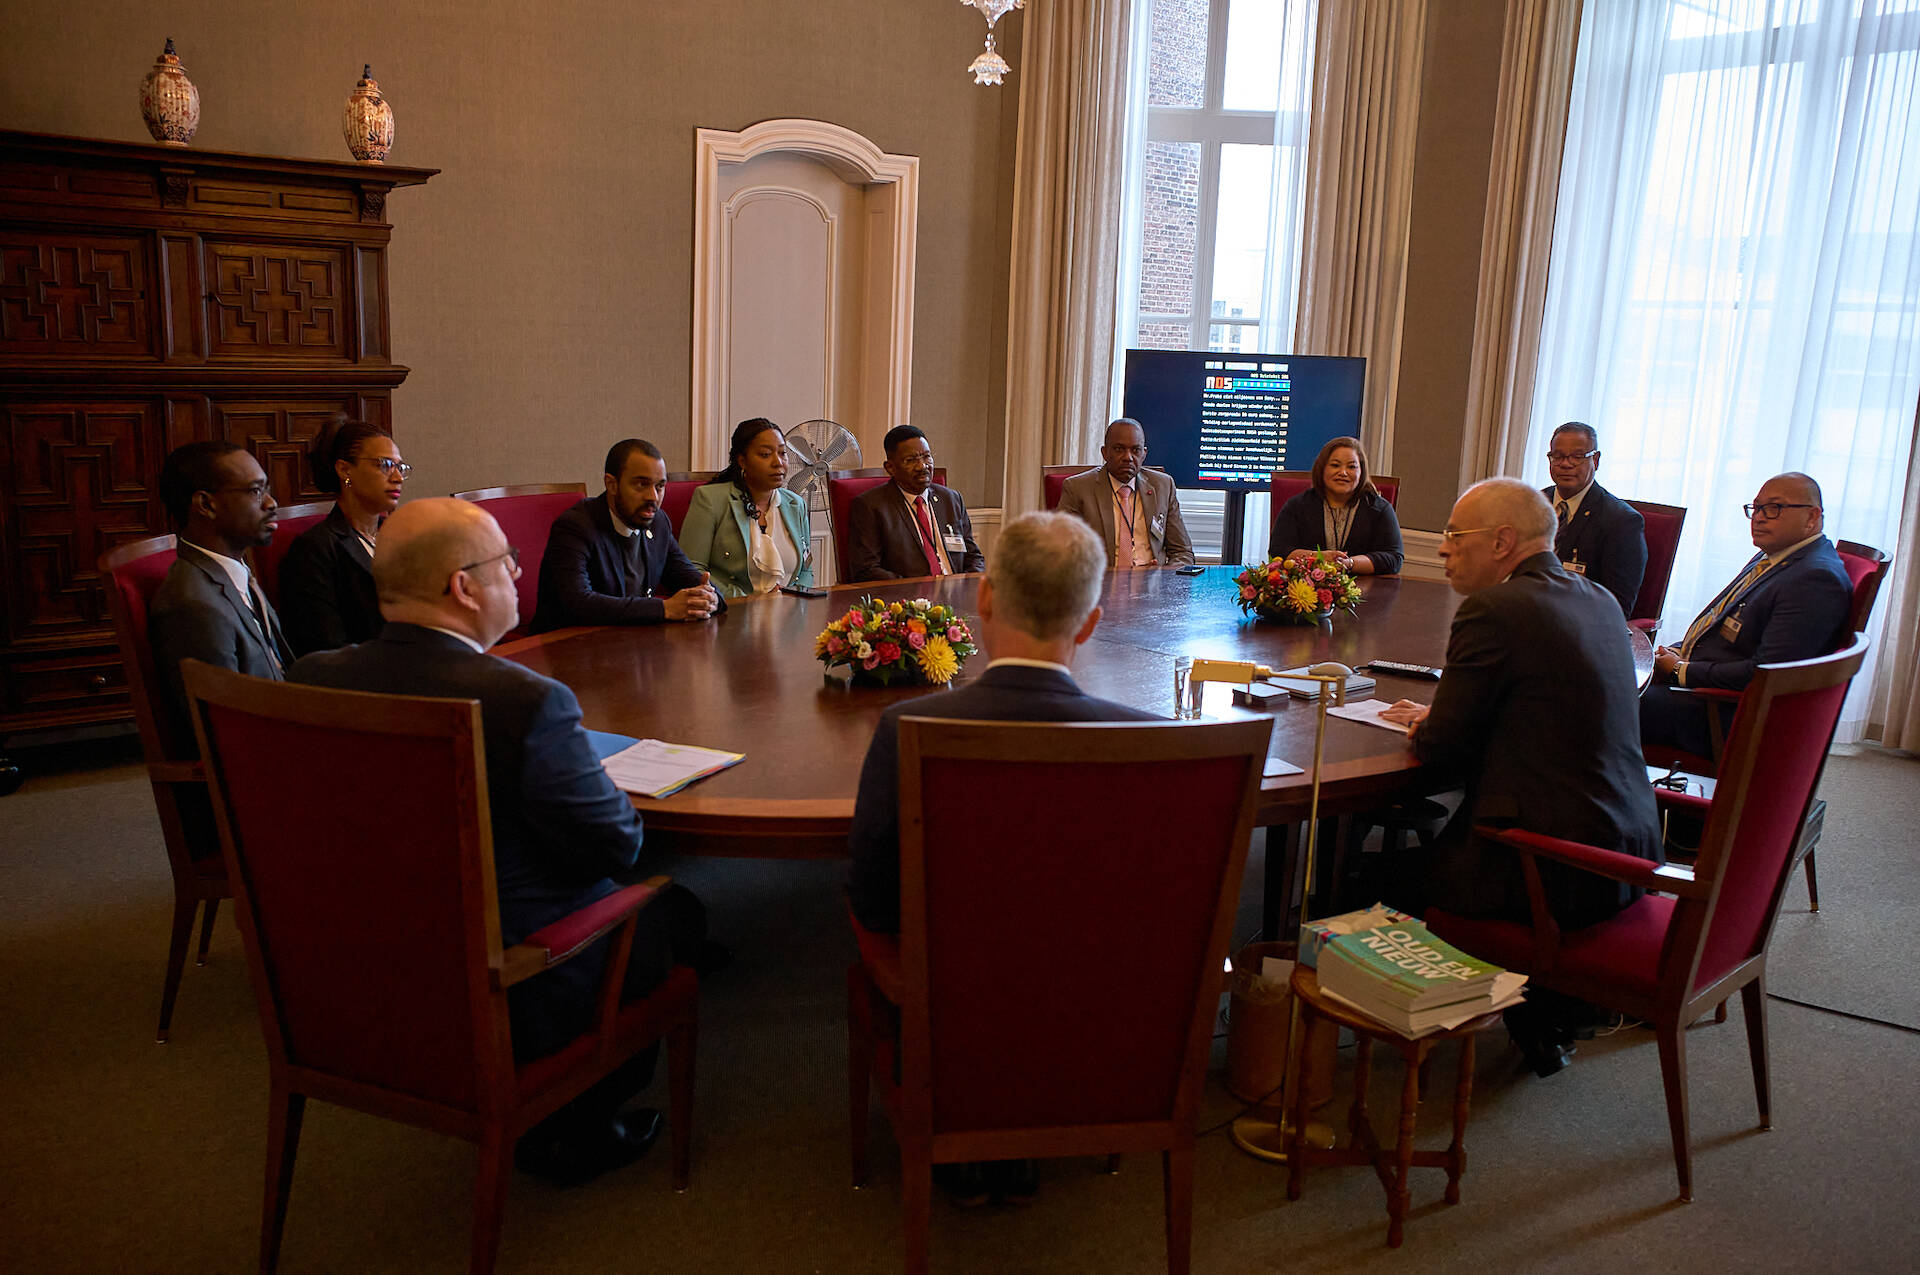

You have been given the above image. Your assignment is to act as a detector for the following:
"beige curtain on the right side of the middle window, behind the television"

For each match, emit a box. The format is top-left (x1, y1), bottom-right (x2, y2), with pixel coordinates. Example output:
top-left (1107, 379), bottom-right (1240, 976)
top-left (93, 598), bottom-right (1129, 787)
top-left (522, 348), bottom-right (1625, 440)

top-left (1294, 0), bottom-right (1427, 472)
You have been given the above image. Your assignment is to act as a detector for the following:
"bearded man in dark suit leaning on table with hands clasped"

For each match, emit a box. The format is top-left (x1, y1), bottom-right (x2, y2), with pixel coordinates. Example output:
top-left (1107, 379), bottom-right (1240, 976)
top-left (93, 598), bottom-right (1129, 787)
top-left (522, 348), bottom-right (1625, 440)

top-left (532, 438), bottom-right (726, 634)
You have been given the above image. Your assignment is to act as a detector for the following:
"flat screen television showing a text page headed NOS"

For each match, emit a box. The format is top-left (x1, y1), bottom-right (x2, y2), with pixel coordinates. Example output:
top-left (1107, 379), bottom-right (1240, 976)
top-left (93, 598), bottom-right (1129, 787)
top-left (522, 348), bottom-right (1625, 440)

top-left (1121, 349), bottom-right (1367, 492)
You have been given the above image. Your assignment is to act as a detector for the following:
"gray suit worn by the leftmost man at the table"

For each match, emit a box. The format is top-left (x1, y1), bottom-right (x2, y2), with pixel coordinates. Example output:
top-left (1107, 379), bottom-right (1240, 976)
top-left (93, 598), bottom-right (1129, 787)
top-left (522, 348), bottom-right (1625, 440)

top-left (146, 540), bottom-right (294, 757)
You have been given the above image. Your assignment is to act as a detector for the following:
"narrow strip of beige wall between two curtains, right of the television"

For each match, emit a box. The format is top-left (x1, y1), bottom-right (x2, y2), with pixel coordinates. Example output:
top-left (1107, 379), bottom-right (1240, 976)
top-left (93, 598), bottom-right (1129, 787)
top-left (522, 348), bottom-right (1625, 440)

top-left (1392, 0), bottom-right (1505, 530)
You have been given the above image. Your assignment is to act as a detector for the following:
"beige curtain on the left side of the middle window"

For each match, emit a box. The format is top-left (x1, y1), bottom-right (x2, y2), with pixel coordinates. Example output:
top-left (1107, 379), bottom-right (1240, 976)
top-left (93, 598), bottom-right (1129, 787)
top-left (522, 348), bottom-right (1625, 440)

top-left (1002, 0), bottom-right (1131, 518)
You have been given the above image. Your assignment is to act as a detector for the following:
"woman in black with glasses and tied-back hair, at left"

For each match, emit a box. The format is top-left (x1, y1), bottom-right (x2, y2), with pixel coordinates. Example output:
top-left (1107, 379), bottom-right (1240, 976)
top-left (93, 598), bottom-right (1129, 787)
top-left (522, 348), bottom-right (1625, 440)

top-left (280, 421), bottom-right (413, 655)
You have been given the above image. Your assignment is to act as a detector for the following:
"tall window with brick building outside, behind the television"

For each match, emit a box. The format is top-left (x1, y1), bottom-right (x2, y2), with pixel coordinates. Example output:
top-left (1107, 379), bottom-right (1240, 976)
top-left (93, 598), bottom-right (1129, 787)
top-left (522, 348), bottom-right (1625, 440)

top-left (1114, 0), bottom-right (1315, 557)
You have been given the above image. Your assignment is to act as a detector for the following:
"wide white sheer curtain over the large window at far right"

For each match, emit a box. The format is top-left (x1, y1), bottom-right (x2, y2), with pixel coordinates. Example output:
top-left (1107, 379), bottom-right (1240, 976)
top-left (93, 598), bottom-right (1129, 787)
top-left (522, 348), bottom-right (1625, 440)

top-left (1526, 0), bottom-right (1920, 737)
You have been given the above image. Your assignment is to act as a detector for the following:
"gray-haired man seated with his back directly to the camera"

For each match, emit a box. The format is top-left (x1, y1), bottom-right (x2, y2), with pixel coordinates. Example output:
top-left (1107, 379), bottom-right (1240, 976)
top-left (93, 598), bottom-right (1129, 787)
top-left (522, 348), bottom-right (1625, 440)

top-left (847, 513), bottom-right (1154, 1204)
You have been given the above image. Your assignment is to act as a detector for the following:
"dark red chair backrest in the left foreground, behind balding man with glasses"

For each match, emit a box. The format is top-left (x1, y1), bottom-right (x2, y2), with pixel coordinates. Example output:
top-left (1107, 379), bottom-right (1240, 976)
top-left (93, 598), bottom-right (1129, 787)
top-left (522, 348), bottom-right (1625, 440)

top-left (184, 661), bottom-right (513, 1112)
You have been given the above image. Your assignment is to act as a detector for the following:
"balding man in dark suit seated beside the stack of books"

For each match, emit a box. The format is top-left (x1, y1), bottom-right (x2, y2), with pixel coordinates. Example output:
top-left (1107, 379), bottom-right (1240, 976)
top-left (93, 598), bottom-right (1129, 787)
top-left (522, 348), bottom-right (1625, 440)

top-left (1386, 478), bottom-right (1661, 1075)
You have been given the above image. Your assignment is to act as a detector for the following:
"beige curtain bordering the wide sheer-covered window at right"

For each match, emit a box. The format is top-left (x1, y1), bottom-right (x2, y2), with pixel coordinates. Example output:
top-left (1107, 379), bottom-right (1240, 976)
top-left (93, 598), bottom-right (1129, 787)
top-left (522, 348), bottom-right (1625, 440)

top-left (1459, 0), bottom-right (1580, 488)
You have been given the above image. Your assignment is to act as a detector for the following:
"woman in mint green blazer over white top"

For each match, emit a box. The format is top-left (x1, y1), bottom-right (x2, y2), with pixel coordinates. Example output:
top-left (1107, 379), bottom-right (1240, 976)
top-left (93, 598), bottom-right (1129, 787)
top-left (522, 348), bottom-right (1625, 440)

top-left (680, 417), bottom-right (814, 597)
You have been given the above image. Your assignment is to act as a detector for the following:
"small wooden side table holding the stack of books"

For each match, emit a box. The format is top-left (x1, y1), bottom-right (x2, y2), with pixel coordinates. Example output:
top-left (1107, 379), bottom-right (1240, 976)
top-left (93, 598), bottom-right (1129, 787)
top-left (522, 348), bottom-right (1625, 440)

top-left (1286, 966), bottom-right (1500, 1248)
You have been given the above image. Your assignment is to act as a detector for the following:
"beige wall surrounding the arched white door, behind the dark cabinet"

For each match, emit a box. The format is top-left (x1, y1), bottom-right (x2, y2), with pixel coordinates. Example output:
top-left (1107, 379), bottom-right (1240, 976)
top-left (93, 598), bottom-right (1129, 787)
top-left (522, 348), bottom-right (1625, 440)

top-left (0, 0), bottom-right (1018, 505)
